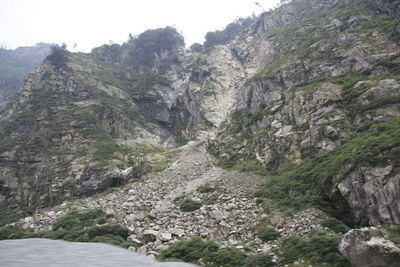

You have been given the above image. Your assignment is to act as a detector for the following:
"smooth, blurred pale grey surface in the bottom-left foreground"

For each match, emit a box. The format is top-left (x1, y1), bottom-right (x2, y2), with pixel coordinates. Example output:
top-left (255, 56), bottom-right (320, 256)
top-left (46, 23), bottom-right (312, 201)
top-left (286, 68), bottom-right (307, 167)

top-left (0, 238), bottom-right (195, 267)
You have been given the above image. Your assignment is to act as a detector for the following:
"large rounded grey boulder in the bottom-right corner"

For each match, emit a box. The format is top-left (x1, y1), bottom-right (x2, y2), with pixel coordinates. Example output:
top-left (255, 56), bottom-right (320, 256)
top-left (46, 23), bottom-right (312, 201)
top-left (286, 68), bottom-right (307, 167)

top-left (339, 227), bottom-right (400, 267)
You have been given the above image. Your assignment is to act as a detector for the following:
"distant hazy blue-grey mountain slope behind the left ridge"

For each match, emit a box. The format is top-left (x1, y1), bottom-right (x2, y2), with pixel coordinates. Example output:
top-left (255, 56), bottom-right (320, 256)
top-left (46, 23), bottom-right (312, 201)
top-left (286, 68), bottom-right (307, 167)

top-left (0, 43), bottom-right (51, 105)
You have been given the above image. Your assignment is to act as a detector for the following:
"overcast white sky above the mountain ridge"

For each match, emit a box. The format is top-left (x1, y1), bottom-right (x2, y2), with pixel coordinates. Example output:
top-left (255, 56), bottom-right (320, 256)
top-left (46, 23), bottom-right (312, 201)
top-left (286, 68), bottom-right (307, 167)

top-left (0, 0), bottom-right (279, 52)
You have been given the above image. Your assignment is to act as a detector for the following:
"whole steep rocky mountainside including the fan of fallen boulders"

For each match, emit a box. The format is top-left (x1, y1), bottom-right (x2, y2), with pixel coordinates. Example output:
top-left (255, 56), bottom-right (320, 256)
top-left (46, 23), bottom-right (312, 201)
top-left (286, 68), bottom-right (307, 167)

top-left (0, 0), bottom-right (400, 266)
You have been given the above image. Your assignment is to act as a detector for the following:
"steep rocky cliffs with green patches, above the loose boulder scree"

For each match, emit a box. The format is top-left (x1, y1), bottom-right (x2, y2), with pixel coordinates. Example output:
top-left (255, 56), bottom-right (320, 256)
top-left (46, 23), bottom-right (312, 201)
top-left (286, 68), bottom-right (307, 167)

top-left (0, 0), bottom-right (400, 233)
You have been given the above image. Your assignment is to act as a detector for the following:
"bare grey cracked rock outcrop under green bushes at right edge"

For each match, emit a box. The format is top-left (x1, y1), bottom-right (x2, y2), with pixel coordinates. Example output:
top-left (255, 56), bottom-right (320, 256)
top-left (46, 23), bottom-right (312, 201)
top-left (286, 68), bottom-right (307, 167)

top-left (338, 165), bottom-right (400, 225)
